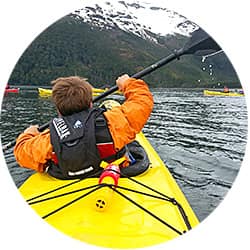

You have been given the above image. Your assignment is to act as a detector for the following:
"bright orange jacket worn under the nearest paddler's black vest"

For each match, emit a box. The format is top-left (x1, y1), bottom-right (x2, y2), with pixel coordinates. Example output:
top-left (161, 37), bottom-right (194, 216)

top-left (14, 78), bottom-right (153, 172)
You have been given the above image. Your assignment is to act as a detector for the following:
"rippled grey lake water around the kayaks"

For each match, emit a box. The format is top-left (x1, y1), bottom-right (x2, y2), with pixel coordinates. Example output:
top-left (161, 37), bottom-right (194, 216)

top-left (0, 89), bottom-right (247, 220)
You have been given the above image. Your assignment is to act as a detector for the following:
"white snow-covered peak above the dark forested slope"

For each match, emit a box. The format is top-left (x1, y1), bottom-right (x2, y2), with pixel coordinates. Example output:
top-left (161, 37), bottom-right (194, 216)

top-left (73, 0), bottom-right (198, 42)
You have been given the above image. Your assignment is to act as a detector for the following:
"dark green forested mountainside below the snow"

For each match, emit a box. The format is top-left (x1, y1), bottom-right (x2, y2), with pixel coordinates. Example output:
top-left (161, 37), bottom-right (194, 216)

top-left (9, 15), bottom-right (240, 87)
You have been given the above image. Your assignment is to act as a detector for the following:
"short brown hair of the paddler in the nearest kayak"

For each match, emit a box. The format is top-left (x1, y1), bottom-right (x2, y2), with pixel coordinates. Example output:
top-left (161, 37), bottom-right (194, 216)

top-left (51, 76), bottom-right (92, 116)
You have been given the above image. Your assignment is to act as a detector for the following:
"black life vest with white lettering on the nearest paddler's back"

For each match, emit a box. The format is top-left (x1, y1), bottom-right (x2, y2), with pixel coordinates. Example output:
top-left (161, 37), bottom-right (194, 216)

top-left (47, 108), bottom-right (125, 179)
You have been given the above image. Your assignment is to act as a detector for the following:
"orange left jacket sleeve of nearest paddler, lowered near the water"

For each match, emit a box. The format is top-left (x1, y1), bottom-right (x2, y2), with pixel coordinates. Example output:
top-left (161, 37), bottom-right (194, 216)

top-left (14, 130), bottom-right (52, 172)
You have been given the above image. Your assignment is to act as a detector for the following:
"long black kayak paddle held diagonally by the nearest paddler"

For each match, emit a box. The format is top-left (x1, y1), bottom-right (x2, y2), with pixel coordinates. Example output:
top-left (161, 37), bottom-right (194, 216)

top-left (2, 28), bottom-right (221, 151)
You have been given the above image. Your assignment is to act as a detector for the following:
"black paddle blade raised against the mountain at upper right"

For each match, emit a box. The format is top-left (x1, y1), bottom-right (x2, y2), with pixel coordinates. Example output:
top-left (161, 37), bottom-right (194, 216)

top-left (183, 28), bottom-right (221, 55)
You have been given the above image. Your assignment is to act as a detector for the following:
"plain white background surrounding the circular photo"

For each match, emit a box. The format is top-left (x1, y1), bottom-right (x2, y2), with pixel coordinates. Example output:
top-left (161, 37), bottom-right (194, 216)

top-left (0, 0), bottom-right (250, 250)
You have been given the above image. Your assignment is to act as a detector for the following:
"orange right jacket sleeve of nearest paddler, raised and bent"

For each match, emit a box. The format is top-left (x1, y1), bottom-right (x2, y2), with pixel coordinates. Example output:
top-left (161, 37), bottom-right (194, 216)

top-left (104, 78), bottom-right (153, 150)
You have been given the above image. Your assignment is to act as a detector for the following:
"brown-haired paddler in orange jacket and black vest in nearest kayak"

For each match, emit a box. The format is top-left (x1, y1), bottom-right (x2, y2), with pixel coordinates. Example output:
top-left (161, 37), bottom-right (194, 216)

top-left (14, 74), bottom-right (153, 179)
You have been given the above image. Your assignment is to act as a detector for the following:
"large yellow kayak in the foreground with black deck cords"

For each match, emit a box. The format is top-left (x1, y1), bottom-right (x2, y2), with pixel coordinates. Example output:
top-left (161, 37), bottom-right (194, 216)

top-left (19, 101), bottom-right (199, 248)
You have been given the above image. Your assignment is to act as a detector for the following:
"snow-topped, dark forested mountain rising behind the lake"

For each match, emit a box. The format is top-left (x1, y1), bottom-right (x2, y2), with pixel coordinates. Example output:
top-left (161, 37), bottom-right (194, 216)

top-left (9, 0), bottom-right (240, 87)
